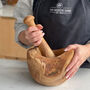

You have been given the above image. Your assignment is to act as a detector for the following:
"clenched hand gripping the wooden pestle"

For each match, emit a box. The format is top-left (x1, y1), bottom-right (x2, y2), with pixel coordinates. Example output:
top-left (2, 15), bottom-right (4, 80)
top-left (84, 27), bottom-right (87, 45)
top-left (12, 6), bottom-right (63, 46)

top-left (25, 24), bottom-right (45, 46)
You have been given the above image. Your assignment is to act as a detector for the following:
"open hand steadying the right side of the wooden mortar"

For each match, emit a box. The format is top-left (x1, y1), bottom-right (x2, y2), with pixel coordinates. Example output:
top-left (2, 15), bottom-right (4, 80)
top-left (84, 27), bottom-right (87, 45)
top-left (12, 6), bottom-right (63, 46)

top-left (65, 44), bottom-right (90, 79)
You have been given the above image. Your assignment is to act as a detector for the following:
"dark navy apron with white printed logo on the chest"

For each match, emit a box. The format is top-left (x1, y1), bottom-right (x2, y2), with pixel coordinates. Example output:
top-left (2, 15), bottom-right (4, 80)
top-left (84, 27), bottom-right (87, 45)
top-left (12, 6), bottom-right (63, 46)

top-left (33, 0), bottom-right (90, 50)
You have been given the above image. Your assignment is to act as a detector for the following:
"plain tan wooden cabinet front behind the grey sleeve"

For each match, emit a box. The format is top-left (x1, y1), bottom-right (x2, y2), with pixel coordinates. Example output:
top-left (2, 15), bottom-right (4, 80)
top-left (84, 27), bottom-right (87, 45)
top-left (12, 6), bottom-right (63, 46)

top-left (0, 18), bottom-right (27, 60)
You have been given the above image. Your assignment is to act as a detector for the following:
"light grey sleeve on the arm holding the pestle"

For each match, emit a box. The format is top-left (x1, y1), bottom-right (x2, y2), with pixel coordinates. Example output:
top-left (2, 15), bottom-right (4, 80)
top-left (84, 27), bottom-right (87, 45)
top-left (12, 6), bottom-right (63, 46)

top-left (14, 0), bottom-right (33, 48)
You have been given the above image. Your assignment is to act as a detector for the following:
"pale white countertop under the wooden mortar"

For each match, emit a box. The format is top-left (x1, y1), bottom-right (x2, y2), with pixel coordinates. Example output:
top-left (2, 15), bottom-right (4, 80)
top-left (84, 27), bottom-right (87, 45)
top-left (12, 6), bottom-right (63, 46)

top-left (0, 59), bottom-right (90, 90)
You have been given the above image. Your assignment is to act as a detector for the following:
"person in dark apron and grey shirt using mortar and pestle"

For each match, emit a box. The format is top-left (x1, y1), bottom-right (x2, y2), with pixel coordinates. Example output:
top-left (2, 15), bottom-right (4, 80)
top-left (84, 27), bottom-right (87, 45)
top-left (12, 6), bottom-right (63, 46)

top-left (14, 0), bottom-right (90, 79)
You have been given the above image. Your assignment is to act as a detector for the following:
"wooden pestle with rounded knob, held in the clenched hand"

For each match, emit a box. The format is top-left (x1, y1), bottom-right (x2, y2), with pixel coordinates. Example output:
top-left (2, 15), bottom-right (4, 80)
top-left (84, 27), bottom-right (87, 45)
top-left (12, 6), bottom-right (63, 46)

top-left (24, 15), bottom-right (55, 57)
